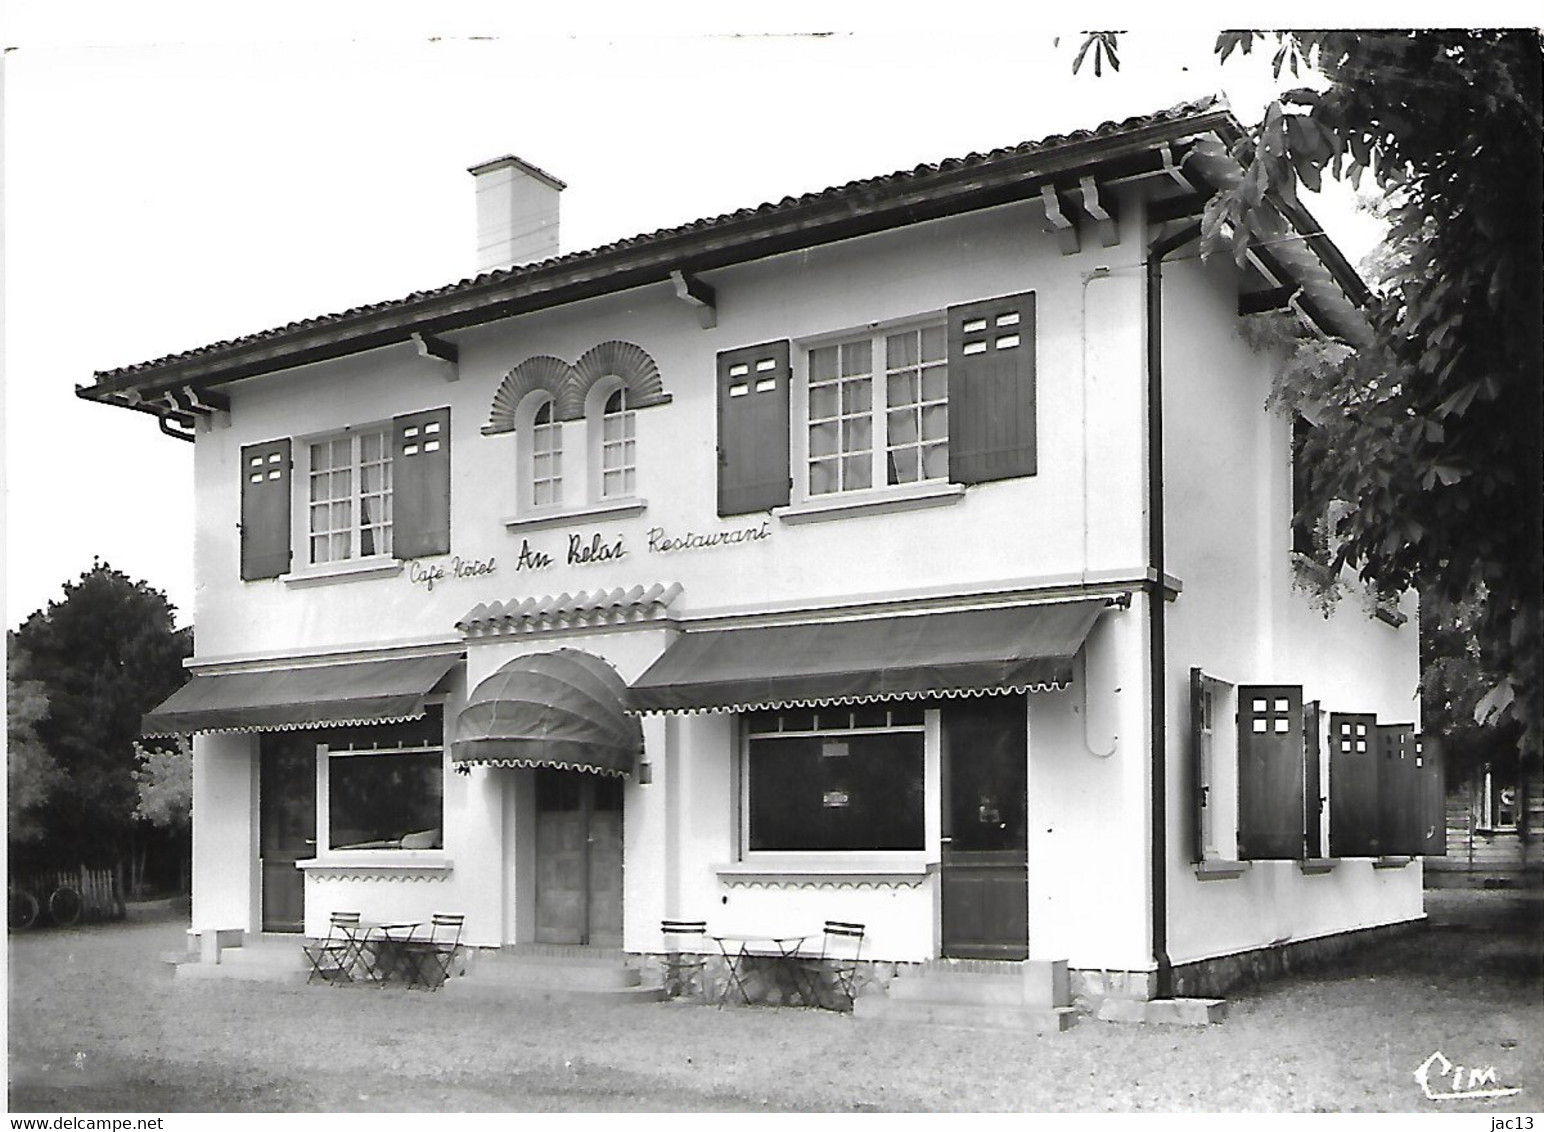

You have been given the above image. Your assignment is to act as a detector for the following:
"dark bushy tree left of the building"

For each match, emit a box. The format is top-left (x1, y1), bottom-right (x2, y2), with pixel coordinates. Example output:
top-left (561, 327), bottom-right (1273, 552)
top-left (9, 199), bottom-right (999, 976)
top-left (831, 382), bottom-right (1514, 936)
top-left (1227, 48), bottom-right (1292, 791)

top-left (12, 562), bottom-right (193, 865)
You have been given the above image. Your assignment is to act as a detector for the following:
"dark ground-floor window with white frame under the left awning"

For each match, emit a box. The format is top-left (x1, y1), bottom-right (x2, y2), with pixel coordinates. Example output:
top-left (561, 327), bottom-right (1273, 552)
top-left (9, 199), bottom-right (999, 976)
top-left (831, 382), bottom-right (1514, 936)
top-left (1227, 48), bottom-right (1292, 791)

top-left (318, 707), bottom-right (445, 851)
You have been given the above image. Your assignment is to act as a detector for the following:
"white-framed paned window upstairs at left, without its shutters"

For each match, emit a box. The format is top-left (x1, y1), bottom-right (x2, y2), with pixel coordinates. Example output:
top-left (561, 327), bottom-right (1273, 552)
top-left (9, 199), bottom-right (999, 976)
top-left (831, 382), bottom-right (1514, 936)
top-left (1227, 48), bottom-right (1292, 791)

top-left (307, 426), bottom-right (392, 565)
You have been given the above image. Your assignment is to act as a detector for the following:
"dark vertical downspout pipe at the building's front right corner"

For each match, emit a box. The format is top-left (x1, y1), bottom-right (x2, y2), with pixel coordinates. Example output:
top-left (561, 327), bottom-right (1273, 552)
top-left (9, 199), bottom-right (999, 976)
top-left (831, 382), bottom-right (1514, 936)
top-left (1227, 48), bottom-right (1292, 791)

top-left (1146, 222), bottom-right (1201, 998)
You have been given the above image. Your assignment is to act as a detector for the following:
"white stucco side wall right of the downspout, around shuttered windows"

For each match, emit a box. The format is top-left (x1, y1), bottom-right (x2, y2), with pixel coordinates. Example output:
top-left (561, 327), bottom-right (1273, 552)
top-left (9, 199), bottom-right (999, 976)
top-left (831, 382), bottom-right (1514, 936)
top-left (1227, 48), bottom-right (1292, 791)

top-left (1164, 251), bottom-right (1422, 964)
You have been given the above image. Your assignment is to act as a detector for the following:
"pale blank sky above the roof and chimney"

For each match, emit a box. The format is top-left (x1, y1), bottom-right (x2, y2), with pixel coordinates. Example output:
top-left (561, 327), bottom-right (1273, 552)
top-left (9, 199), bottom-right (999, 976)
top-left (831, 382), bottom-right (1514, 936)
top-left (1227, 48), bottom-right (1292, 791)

top-left (0, 0), bottom-right (1506, 627)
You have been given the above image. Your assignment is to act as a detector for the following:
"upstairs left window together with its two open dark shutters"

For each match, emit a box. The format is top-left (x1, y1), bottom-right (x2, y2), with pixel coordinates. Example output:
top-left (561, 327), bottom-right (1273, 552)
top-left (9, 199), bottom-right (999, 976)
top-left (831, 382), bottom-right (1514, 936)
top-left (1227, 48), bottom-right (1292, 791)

top-left (241, 408), bottom-right (451, 581)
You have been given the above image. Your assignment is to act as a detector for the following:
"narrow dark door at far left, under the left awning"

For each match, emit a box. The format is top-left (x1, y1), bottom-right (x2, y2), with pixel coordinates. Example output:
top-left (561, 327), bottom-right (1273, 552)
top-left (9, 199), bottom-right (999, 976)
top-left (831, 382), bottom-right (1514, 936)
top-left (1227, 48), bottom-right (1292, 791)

top-left (258, 732), bottom-right (317, 931)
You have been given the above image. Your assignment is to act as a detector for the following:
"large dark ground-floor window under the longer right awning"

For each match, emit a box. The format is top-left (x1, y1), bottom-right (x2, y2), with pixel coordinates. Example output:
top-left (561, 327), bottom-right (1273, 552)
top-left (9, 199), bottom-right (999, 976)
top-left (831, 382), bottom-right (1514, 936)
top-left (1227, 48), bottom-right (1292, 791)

top-left (744, 704), bottom-right (925, 852)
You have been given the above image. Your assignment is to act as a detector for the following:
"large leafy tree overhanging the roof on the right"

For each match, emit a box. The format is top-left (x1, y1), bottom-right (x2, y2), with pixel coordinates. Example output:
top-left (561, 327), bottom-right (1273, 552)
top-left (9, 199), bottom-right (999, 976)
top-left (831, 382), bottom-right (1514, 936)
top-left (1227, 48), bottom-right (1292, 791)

top-left (1075, 29), bottom-right (1544, 754)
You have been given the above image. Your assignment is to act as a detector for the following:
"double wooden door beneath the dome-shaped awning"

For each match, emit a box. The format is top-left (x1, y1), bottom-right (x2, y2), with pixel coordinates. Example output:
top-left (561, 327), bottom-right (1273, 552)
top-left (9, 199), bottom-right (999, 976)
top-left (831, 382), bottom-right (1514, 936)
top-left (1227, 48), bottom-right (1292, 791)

top-left (536, 769), bottom-right (622, 947)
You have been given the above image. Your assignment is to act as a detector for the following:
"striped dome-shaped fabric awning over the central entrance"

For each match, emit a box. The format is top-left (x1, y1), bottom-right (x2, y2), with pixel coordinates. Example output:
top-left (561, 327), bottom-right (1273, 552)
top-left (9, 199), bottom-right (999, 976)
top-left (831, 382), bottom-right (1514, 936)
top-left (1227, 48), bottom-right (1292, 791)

top-left (451, 649), bottom-right (644, 777)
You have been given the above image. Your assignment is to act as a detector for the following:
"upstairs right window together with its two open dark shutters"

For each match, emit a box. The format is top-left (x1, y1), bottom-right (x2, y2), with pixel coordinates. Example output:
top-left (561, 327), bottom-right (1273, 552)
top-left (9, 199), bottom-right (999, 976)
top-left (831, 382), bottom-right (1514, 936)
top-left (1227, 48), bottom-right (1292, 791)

top-left (718, 292), bottom-right (1036, 516)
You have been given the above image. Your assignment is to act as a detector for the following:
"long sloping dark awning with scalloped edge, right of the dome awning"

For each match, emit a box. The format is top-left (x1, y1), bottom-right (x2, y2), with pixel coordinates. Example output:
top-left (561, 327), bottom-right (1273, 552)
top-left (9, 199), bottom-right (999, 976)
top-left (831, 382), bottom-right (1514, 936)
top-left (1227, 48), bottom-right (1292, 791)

top-left (631, 599), bottom-right (1106, 713)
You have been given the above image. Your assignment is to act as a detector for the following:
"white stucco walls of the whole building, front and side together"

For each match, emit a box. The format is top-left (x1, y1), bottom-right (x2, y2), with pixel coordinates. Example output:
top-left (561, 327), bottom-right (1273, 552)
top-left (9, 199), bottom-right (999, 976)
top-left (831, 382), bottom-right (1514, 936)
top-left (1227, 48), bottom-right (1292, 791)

top-left (175, 176), bottom-right (1419, 970)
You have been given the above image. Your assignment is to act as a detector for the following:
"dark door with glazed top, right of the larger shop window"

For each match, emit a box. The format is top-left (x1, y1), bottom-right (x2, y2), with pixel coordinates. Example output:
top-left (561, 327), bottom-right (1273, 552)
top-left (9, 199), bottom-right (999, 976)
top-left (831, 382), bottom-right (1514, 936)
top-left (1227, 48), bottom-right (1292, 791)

top-left (940, 695), bottom-right (1030, 959)
